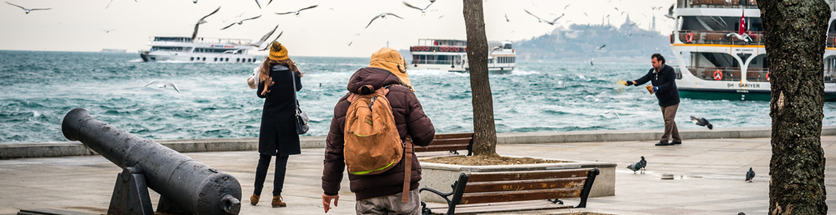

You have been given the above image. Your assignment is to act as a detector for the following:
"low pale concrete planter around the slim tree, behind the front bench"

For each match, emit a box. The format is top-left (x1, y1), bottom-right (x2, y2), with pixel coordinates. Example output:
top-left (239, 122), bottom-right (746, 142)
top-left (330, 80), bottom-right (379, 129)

top-left (419, 156), bottom-right (616, 203)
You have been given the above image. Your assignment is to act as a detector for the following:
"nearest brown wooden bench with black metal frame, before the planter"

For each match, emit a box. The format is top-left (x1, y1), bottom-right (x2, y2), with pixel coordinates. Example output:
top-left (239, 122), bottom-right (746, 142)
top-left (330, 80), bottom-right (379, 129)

top-left (419, 168), bottom-right (599, 215)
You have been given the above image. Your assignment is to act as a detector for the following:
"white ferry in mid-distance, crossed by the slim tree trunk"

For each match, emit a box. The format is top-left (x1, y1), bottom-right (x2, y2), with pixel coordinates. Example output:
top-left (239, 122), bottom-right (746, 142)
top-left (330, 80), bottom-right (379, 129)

top-left (409, 39), bottom-right (517, 72)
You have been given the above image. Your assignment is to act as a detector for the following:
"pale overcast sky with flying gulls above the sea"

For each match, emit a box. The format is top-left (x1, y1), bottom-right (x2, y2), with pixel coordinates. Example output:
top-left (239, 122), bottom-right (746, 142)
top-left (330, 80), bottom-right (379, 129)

top-left (0, 0), bottom-right (674, 57)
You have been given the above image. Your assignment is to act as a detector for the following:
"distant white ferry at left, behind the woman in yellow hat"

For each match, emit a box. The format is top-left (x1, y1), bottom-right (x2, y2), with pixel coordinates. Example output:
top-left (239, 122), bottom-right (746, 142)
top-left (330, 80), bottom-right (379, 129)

top-left (139, 37), bottom-right (257, 63)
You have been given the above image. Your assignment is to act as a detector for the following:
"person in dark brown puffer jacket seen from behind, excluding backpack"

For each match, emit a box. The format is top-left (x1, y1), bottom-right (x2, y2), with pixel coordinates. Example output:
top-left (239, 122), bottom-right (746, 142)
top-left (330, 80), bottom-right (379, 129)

top-left (322, 48), bottom-right (435, 214)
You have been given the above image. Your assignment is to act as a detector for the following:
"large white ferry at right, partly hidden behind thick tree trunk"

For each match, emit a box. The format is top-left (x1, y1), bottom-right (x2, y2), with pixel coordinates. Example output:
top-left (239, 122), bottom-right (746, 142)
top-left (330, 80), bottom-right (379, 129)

top-left (668, 0), bottom-right (836, 101)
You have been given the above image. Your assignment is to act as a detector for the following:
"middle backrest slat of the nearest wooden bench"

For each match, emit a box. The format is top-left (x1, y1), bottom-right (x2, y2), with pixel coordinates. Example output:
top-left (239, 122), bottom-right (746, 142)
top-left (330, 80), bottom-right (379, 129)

top-left (464, 177), bottom-right (586, 193)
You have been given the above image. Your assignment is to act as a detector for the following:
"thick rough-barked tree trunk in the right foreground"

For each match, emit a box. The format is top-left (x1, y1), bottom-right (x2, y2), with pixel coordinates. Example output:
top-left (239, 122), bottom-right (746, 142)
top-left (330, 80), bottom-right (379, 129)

top-left (758, 0), bottom-right (830, 215)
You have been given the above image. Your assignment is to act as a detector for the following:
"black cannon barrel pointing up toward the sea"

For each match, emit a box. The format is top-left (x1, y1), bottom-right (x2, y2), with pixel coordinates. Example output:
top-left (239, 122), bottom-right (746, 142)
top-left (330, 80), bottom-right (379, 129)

top-left (61, 108), bottom-right (241, 214)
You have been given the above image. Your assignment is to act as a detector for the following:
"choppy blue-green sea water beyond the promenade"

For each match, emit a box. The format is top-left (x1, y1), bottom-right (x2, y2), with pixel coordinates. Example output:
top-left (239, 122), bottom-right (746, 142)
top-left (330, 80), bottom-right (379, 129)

top-left (0, 51), bottom-right (836, 144)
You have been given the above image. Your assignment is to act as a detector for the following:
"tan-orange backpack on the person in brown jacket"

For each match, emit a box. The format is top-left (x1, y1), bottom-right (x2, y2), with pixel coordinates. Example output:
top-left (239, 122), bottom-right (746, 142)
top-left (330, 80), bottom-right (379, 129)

top-left (343, 85), bottom-right (404, 175)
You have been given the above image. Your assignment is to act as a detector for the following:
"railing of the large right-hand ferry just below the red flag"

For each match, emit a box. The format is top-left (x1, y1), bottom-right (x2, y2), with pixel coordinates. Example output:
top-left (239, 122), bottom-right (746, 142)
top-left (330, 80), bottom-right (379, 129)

top-left (671, 30), bottom-right (764, 45)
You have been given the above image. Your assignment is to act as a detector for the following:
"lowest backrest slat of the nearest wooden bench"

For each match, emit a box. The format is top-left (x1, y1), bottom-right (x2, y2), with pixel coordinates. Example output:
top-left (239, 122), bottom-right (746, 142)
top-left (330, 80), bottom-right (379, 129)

top-left (460, 188), bottom-right (581, 204)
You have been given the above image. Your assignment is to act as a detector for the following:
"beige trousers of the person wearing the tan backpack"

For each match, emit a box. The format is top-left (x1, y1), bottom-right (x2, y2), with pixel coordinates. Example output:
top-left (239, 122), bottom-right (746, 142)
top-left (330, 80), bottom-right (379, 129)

top-left (354, 189), bottom-right (421, 215)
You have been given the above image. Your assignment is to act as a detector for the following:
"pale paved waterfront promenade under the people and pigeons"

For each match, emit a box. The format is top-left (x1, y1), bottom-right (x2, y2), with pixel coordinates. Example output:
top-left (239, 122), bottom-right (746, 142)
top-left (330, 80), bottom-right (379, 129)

top-left (0, 128), bottom-right (836, 214)
